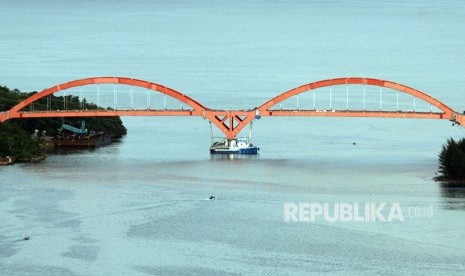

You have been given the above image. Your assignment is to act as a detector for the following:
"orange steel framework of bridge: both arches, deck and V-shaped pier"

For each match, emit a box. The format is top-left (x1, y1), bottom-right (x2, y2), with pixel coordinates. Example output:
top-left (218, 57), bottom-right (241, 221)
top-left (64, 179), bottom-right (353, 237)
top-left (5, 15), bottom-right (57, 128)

top-left (0, 77), bottom-right (465, 139)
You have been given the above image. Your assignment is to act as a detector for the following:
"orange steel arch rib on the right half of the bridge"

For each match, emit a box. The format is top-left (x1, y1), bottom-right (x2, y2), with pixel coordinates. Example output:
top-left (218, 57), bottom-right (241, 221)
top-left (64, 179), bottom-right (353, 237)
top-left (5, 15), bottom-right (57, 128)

top-left (258, 77), bottom-right (456, 119)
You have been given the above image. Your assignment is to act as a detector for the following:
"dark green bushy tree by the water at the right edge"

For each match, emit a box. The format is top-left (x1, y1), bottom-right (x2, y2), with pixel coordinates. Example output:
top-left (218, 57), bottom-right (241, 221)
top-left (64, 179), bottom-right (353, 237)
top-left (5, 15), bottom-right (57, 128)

top-left (437, 138), bottom-right (465, 182)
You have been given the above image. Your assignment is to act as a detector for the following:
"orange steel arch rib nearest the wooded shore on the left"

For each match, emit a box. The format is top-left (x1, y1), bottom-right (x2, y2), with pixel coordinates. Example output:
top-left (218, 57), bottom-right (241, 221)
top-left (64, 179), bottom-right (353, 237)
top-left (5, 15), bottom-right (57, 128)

top-left (9, 77), bottom-right (205, 118)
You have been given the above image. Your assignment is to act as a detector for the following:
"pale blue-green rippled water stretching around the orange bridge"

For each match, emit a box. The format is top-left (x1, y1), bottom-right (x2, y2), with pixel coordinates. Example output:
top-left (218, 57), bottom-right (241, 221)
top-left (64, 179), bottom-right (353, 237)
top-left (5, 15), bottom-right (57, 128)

top-left (0, 1), bottom-right (465, 275)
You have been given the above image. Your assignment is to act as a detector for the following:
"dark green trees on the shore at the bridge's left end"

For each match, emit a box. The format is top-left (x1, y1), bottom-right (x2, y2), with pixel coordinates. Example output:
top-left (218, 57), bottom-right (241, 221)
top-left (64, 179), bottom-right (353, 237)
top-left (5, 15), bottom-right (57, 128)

top-left (0, 86), bottom-right (127, 160)
